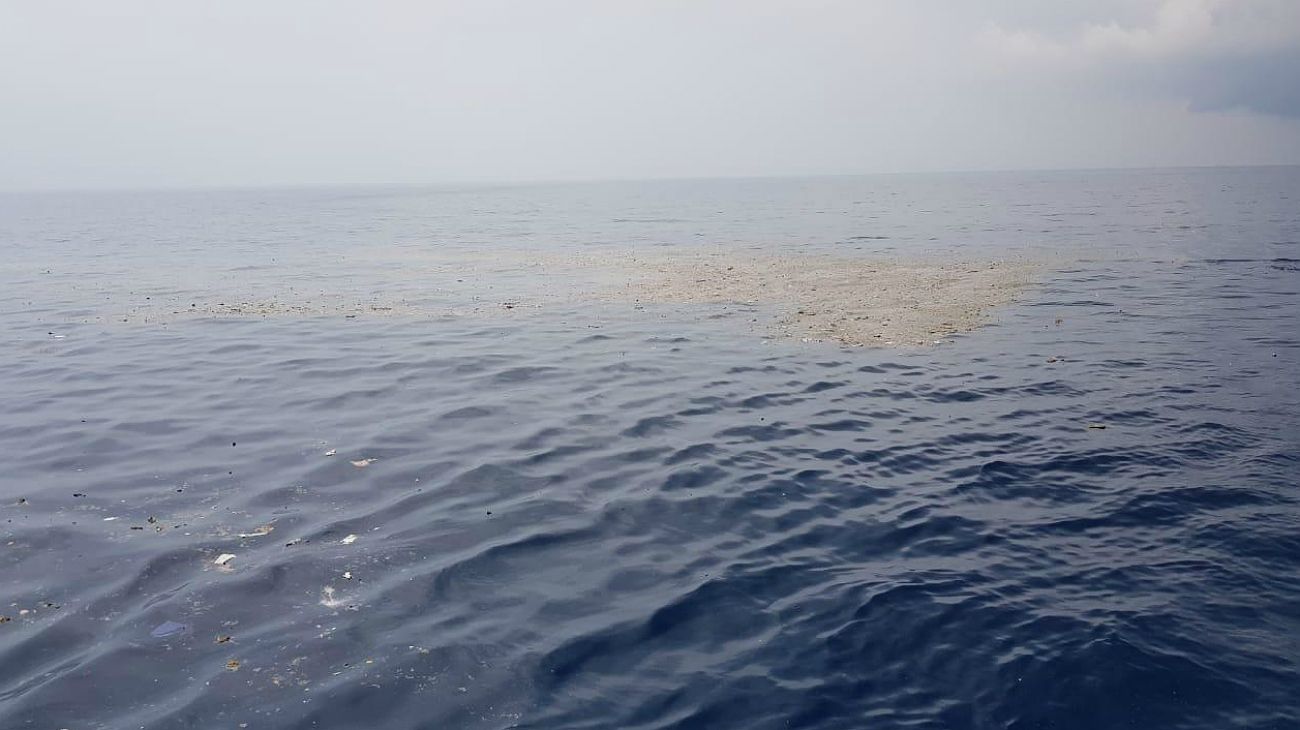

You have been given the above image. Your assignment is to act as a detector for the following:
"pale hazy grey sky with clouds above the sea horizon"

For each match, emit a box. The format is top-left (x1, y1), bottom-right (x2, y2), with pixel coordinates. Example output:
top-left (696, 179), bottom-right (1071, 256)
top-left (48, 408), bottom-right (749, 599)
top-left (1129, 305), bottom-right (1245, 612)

top-left (0, 0), bottom-right (1300, 188)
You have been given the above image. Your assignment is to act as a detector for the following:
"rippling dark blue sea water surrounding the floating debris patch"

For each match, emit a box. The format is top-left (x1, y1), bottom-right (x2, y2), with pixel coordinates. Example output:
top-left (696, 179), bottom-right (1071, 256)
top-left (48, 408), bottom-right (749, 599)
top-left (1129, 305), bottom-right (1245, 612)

top-left (0, 168), bottom-right (1300, 730)
